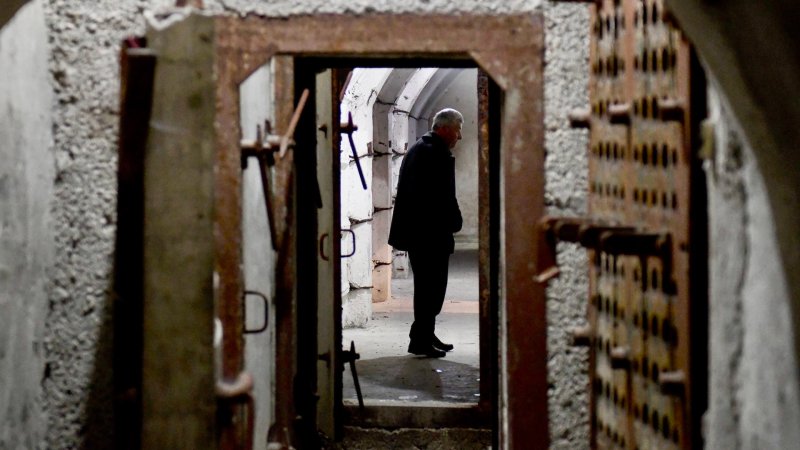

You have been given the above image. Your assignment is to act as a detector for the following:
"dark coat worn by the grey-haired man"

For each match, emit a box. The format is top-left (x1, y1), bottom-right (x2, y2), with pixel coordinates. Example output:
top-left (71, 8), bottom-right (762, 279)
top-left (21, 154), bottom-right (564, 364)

top-left (389, 132), bottom-right (462, 254)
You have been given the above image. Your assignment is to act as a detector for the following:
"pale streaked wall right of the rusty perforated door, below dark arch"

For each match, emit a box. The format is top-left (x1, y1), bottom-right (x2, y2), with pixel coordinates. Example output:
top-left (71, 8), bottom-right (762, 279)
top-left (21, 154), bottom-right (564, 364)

top-left (706, 84), bottom-right (800, 449)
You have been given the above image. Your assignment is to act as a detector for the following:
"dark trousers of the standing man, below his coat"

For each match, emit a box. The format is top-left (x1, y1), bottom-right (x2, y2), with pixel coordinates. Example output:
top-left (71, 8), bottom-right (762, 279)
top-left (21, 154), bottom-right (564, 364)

top-left (408, 250), bottom-right (450, 346)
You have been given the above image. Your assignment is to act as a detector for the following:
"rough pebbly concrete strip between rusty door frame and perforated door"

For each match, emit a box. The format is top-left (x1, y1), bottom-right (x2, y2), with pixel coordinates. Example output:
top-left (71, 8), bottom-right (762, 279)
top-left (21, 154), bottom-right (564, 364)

top-left (544, 2), bottom-right (589, 449)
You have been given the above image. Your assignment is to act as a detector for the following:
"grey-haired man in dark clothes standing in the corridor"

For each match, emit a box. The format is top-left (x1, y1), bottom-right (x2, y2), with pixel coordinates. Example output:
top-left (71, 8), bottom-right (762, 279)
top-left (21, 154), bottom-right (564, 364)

top-left (389, 108), bottom-right (464, 358)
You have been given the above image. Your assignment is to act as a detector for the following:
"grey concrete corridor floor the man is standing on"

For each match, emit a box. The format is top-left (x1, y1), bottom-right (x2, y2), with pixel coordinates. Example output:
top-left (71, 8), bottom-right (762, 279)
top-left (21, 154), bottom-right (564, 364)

top-left (343, 250), bottom-right (480, 405)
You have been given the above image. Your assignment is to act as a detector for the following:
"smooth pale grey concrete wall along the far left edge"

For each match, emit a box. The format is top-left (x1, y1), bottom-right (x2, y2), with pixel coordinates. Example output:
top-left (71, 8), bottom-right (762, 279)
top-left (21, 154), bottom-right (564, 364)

top-left (0, 1), bottom-right (55, 449)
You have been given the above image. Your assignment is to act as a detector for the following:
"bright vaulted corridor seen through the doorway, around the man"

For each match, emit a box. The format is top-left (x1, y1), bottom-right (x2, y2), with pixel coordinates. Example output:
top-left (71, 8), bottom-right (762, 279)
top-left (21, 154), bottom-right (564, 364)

top-left (340, 67), bottom-right (481, 412)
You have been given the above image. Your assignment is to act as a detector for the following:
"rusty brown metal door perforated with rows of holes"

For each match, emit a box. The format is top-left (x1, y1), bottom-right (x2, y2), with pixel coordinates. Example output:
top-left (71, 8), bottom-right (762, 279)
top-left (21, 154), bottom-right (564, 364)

top-left (545, 0), bottom-right (707, 449)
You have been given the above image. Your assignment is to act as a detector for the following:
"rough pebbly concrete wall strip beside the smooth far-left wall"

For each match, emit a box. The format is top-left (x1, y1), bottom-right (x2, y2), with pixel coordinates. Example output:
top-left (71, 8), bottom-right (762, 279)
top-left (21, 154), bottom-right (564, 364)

top-left (42, 0), bottom-right (159, 449)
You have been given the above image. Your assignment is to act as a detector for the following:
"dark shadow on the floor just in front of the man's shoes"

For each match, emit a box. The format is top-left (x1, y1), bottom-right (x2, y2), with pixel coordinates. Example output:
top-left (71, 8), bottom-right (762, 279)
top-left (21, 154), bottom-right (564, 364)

top-left (343, 355), bottom-right (480, 403)
